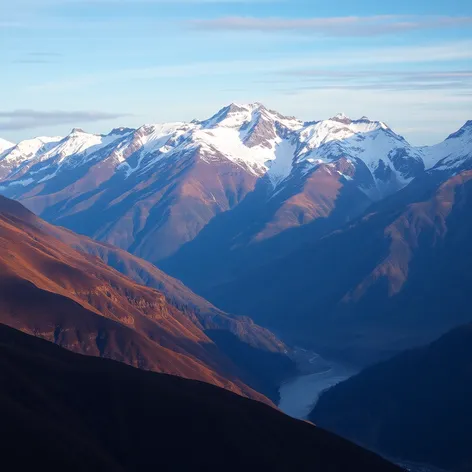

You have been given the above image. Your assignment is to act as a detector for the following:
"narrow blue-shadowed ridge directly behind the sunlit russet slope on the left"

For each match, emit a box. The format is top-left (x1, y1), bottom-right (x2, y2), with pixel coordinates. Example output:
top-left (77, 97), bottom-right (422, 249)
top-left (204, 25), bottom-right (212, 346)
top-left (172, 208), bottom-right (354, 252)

top-left (0, 196), bottom-right (295, 401)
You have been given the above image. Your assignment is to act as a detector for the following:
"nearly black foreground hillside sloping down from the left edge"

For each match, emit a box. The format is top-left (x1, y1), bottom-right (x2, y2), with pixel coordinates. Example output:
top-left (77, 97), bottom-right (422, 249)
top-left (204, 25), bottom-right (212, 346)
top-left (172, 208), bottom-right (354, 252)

top-left (0, 325), bottom-right (400, 472)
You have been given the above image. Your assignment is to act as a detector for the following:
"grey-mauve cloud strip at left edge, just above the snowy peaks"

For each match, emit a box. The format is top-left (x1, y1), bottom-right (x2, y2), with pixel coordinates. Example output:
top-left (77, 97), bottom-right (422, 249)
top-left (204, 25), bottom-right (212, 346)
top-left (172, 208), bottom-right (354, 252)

top-left (0, 110), bottom-right (129, 131)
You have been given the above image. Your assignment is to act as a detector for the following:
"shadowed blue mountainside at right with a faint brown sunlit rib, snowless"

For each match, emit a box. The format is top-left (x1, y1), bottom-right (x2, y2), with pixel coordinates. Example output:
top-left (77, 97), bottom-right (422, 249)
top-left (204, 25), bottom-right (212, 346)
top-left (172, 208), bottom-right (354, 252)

top-left (207, 165), bottom-right (472, 364)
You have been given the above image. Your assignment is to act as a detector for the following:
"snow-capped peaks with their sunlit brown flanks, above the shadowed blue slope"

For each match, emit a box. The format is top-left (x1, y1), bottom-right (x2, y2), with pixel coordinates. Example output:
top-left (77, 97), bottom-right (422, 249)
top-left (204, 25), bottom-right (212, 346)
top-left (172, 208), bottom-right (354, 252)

top-left (0, 103), bottom-right (472, 261)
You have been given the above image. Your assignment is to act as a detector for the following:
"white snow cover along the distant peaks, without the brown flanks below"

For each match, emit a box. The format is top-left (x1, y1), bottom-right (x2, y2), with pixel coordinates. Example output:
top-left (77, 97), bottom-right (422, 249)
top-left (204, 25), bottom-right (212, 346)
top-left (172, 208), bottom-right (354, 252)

top-left (0, 103), bottom-right (460, 198)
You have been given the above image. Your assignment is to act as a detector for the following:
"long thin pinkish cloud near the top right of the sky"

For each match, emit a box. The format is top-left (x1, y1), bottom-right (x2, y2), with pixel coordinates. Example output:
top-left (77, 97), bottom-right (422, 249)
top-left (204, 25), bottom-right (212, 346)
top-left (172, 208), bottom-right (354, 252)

top-left (189, 15), bottom-right (472, 37)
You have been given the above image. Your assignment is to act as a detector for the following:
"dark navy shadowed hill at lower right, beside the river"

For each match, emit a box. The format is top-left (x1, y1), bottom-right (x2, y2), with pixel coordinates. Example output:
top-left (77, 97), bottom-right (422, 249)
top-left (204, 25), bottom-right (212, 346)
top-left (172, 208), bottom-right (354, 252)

top-left (310, 324), bottom-right (472, 472)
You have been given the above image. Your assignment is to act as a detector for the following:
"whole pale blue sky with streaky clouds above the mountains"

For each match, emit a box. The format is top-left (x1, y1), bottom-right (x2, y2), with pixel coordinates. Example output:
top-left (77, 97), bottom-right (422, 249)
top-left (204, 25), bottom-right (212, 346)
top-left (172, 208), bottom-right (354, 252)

top-left (0, 0), bottom-right (472, 144)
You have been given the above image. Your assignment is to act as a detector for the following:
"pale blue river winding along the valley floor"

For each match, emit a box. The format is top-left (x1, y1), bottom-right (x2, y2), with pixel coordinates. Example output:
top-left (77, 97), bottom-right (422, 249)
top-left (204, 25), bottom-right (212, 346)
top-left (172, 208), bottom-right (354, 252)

top-left (278, 349), bottom-right (357, 419)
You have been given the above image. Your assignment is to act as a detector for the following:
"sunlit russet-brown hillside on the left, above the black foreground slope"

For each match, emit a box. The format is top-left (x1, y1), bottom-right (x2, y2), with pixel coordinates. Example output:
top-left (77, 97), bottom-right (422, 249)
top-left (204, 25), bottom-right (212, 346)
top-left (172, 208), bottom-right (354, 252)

top-left (0, 195), bottom-right (292, 400)
